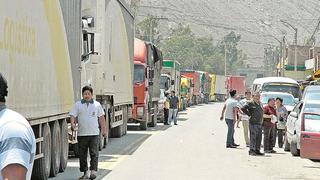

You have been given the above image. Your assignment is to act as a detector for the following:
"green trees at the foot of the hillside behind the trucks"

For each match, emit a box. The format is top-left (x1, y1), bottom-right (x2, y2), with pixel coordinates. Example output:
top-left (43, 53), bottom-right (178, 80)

top-left (136, 16), bottom-right (246, 74)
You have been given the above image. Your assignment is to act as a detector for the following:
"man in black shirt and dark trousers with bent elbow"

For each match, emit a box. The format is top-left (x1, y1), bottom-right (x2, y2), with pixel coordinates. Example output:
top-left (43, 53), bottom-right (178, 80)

top-left (241, 92), bottom-right (264, 156)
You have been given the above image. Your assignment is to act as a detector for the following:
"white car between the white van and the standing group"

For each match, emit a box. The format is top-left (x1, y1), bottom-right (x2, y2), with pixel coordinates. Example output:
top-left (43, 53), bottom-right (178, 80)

top-left (261, 92), bottom-right (298, 113)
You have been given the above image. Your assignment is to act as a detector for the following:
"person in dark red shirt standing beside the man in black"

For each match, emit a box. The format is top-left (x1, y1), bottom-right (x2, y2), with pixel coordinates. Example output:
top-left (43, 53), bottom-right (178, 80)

top-left (262, 98), bottom-right (277, 153)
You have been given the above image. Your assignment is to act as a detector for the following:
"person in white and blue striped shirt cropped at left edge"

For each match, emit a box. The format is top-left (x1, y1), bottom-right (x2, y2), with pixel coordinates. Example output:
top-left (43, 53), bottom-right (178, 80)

top-left (0, 73), bottom-right (36, 180)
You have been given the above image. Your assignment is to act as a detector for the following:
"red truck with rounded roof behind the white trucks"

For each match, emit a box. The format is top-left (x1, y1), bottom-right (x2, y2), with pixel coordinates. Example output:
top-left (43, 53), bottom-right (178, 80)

top-left (129, 38), bottom-right (163, 130)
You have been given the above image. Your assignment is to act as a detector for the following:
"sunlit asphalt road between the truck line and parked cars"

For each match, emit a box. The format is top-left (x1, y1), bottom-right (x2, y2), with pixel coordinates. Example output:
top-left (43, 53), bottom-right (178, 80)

top-left (54, 103), bottom-right (320, 180)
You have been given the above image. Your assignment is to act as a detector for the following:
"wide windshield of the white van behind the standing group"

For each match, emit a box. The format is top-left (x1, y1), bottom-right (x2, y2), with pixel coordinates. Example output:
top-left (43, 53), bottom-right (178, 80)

top-left (262, 83), bottom-right (300, 98)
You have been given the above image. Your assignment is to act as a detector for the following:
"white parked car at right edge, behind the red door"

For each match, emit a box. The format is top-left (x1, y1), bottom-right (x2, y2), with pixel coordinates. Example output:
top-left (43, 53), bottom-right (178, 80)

top-left (284, 100), bottom-right (320, 156)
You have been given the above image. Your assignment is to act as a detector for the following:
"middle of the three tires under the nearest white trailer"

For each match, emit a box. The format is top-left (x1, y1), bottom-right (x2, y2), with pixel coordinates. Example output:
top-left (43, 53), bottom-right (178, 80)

top-left (50, 121), bottom-right (61, 177)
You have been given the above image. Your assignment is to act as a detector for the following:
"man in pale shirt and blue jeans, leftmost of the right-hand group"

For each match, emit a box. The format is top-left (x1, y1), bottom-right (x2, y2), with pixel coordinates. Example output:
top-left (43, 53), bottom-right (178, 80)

top-left (220, 90), bottom-right (239, 148)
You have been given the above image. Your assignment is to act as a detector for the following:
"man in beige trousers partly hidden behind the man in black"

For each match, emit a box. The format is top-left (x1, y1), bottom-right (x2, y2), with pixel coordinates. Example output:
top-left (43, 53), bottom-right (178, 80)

top-left (238, 91), bottom-right (251, 147)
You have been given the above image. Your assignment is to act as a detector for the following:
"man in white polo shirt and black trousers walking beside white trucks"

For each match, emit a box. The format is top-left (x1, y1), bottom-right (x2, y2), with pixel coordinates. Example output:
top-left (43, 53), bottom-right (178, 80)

top-left (70, 86), bottom-right (107, 179)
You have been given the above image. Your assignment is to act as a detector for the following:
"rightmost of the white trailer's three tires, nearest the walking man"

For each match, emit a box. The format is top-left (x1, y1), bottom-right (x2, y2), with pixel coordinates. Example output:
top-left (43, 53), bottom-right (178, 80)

top-left (60, 119), bottom-right (69, 172)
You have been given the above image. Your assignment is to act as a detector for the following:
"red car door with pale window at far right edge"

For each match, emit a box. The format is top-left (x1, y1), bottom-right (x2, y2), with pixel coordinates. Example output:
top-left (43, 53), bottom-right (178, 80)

top-left (300, 112), bottom-right (320, 160)
